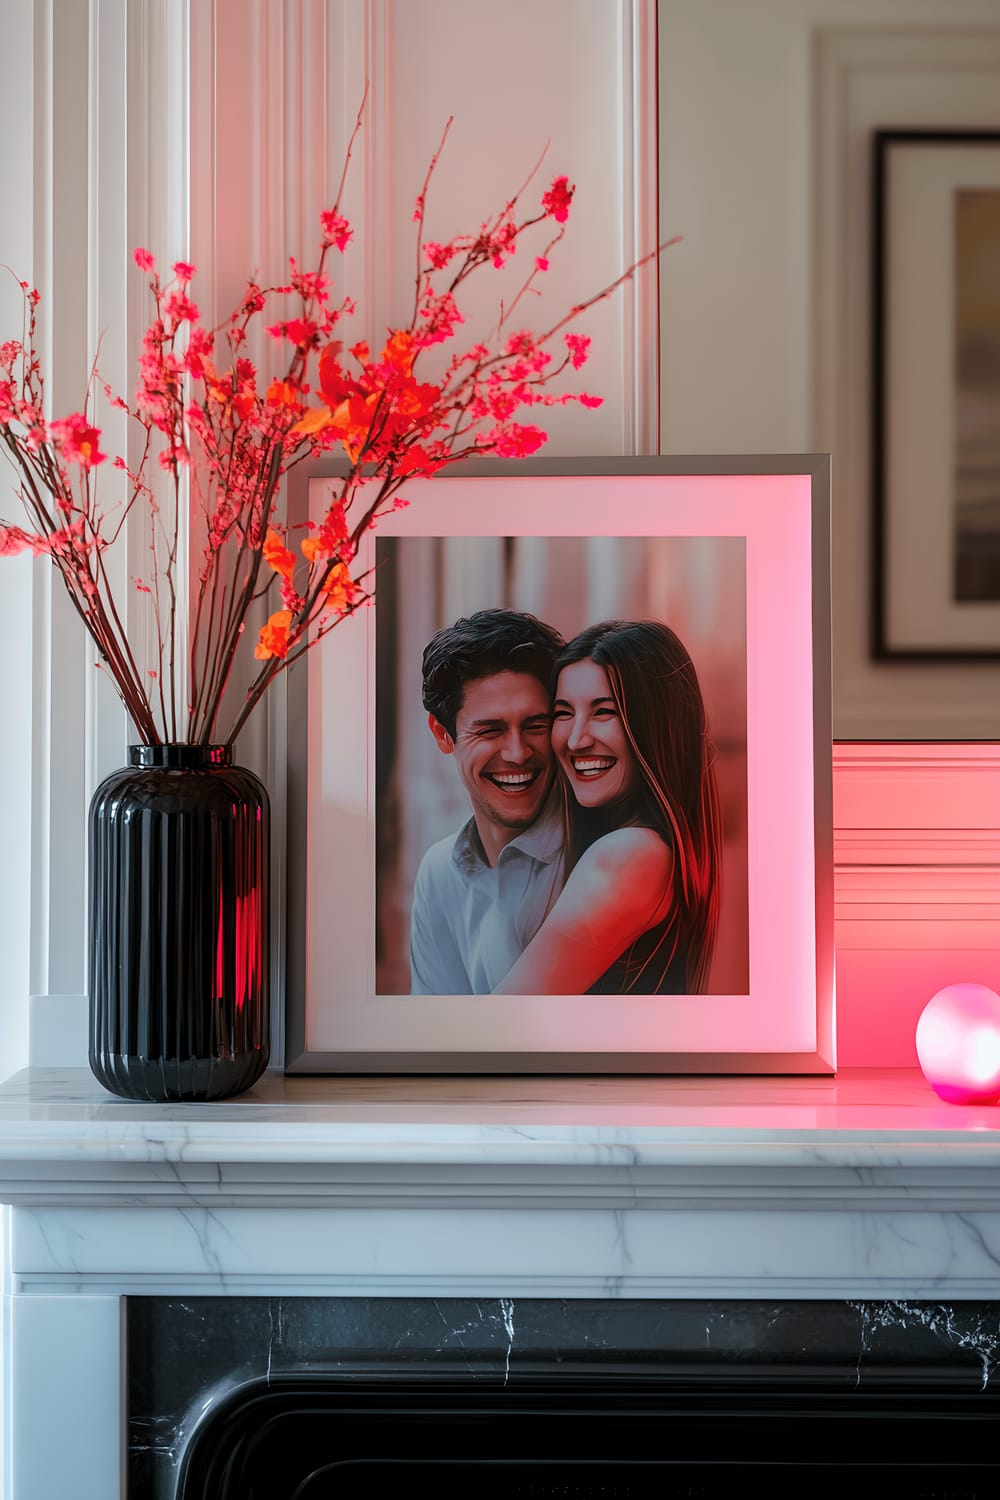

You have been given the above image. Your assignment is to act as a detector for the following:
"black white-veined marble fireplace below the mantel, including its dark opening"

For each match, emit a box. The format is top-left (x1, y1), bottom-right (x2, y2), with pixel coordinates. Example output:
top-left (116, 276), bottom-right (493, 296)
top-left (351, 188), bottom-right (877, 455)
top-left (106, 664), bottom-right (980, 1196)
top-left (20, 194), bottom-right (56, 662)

top-left (127, 1298), bottom-right (1000, 1500)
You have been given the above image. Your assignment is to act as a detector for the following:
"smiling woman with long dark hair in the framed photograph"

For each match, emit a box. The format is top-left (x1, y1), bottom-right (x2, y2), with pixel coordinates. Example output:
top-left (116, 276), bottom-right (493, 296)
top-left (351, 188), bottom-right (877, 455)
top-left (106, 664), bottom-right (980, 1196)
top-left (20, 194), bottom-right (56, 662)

top-left (495, 621), bottom-right (721, 995)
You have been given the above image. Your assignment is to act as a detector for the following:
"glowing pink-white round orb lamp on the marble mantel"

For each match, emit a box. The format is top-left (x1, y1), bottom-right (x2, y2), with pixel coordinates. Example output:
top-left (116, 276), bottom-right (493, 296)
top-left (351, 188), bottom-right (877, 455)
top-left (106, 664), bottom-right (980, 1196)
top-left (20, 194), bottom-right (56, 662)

top-left (916, 984), bottom-right (1000, 1104)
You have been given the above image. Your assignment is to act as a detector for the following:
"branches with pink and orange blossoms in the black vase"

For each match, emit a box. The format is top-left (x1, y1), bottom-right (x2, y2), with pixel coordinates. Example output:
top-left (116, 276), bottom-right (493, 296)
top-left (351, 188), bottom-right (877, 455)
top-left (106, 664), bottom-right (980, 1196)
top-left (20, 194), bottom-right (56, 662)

top-left (0, 114), bottom-right (673, 744)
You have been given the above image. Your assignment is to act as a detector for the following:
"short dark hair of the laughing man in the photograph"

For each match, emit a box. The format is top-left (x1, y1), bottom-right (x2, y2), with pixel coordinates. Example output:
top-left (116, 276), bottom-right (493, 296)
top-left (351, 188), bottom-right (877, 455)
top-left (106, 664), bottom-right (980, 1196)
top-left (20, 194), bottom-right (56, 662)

top-left (423, 609), bottom-right (564, 737)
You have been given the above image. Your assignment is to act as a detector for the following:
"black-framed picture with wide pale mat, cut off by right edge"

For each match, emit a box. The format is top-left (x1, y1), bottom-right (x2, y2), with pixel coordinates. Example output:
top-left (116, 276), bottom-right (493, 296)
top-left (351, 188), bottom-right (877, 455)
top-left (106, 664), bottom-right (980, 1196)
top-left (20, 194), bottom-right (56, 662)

top-left (871, 129), bottom-right (1000, 663)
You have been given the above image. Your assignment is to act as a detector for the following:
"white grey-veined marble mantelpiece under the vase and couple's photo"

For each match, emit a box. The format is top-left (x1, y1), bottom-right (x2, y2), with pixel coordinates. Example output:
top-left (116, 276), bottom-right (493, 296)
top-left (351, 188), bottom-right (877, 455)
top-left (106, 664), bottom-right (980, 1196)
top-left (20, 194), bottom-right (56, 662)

top-left (0, 1070), bottom-right (1000, 1500)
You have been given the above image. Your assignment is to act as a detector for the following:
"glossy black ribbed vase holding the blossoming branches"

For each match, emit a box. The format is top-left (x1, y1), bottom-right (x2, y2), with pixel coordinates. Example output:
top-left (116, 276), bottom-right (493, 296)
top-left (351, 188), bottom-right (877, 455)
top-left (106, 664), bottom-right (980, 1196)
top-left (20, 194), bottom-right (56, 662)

top-left (90, 744), bottom-right (270, 1101)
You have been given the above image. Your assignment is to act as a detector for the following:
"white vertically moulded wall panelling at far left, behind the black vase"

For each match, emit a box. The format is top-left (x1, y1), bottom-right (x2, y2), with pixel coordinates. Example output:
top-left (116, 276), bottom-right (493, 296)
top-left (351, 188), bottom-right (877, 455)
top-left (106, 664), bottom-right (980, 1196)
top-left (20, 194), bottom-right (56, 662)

top-left (0, 0), bottom-right (187, 1073)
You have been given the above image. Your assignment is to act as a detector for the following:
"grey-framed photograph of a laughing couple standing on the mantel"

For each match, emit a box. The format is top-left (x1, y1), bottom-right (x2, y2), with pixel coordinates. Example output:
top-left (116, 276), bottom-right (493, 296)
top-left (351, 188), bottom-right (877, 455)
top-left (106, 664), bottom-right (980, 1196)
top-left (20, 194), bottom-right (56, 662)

top-left (286, 455), bottom-right (835, 1074)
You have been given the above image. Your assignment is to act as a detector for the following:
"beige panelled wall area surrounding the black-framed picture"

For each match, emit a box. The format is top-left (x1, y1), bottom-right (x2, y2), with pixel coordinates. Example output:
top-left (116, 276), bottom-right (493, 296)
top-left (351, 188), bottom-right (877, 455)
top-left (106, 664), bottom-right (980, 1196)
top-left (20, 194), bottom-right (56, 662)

top-left (658, 0), bottom-right (1000, 740)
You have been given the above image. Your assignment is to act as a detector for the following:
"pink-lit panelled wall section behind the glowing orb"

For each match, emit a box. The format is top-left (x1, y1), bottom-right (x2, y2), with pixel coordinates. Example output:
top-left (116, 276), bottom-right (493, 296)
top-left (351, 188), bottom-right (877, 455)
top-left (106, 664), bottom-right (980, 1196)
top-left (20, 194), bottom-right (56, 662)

top-left (834, 741), bottom-right (1000, 1068)
